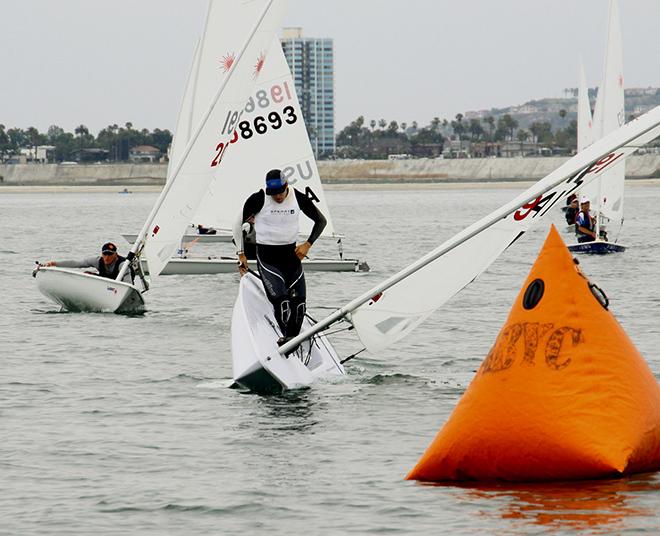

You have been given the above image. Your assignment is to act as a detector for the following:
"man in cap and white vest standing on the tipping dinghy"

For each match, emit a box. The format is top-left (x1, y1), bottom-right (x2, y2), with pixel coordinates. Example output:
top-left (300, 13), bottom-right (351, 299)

top-left (233, 169), bottom-right (327, 345)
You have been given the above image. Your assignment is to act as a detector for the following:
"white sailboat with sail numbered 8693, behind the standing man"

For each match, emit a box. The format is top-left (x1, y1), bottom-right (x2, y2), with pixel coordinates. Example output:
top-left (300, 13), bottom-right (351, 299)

top-left (125, 35), bottom-right (369, 275)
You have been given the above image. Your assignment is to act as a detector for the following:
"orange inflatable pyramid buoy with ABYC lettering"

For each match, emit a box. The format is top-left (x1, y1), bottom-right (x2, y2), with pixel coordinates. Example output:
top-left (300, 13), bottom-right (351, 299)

top-left (407, 226), bottom-right (660, 482)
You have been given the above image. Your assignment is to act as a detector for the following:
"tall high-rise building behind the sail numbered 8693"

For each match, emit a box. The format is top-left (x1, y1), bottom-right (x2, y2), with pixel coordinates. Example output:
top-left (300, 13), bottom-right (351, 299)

top-left (282, 28), bottom-right (335, 158)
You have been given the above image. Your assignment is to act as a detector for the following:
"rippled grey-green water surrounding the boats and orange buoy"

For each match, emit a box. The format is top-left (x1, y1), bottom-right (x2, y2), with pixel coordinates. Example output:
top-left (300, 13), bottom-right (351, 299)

top-left (0, 184), bottom-right (660, 535)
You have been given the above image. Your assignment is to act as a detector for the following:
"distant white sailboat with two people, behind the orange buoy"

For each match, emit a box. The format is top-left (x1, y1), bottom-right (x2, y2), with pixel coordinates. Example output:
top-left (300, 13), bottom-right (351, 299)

top-left (568, 0), bottom-right (626, 254)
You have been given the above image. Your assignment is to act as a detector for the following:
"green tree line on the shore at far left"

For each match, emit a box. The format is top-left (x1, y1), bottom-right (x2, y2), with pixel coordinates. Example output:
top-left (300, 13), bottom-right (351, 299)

top-left (0, 122), bottom-right (172, 162)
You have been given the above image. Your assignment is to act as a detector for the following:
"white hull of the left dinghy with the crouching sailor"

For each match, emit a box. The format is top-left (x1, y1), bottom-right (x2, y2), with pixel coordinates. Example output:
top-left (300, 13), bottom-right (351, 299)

top-left (34, 267), bottom-right (144, 314)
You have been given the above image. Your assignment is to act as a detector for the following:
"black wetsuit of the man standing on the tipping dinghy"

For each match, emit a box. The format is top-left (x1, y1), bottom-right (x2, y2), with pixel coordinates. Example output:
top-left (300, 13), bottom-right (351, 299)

top-left (243, 188), bottom-right (327, 338)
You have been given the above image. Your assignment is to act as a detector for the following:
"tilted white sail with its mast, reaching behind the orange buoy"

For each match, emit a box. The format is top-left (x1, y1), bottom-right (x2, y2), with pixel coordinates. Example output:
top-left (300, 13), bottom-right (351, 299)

top-left (280, 106), bottom-right (660, 353)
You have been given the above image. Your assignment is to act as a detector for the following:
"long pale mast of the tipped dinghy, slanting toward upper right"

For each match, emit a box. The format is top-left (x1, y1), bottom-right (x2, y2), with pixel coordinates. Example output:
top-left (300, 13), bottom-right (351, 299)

top-left (278, 106), bottom-right (660, 355)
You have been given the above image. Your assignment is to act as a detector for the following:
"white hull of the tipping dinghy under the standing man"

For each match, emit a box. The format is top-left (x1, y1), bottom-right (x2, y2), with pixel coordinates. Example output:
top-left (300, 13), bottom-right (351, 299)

top-left (231, 274), bottom-right (344, 393)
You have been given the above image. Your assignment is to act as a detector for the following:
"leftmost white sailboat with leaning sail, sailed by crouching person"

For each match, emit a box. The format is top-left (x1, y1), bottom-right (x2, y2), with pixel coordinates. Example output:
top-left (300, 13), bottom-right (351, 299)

top-left (35, 0), bottom-right (283, 312)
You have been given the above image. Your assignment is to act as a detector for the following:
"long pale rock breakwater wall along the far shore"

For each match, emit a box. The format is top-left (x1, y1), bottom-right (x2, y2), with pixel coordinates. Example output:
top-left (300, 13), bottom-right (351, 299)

top-left (0, 154), bottom-right (660, 186)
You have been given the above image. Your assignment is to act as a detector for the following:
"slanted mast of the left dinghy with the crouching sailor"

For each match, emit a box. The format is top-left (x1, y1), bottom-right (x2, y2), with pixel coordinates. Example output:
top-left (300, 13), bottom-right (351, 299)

top-left (117, 0), bottom-right (275, 281)
